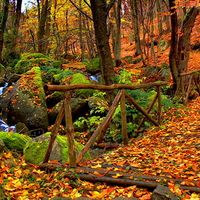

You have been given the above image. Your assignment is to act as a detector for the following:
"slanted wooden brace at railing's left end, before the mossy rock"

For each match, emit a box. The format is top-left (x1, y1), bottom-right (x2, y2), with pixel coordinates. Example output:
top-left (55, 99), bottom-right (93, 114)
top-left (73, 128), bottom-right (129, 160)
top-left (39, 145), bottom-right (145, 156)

top-left (43, 102), bottom-right (64, 163)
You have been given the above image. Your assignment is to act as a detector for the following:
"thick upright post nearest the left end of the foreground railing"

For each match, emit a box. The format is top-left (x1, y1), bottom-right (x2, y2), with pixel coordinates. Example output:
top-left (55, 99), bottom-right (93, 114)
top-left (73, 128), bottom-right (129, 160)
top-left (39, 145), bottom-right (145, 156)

top-left (64, 92), bottom-right (76, 167)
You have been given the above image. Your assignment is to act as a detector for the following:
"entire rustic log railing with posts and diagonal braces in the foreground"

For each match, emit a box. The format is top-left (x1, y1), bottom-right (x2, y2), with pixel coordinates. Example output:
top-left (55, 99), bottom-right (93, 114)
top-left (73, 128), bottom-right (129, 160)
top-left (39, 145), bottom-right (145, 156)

top-left (43, 82), bottom-right (167, 167)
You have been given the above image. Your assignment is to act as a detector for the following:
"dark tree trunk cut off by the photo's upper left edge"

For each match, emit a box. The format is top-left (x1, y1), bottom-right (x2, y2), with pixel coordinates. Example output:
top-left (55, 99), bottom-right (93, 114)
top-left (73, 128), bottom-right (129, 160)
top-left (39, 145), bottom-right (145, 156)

top-left (0, 0), bottom-right (9, 62)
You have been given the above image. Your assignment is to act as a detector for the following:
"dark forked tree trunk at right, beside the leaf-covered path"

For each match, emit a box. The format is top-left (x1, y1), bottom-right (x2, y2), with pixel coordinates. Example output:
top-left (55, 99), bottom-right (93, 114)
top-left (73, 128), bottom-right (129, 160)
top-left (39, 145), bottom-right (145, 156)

top-left (169, 0), bottom-right (199, 94)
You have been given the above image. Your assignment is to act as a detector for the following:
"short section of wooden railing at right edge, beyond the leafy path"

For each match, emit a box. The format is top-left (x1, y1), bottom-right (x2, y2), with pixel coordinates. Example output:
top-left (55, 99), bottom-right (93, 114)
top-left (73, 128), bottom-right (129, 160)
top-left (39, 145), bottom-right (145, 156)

top-left (175, 70), bottom-right (200, 104)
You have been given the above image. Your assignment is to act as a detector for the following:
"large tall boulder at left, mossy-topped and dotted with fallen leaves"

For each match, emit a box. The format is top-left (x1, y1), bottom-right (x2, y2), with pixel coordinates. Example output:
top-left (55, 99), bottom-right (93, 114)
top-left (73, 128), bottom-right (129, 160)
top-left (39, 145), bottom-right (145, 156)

top-left (5, 67), bottom-right (48, 130)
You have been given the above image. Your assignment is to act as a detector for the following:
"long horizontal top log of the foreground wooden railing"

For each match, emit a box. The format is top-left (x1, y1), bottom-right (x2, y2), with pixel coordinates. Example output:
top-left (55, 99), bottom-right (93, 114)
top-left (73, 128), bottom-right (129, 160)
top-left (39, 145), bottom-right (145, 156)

top-left (44, 81), bottom-right (168, 92)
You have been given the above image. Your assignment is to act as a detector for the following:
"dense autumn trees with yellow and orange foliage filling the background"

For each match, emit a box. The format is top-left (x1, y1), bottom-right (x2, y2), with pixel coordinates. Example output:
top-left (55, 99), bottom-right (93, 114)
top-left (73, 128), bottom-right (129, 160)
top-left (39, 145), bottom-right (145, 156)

top-left (0, 0), bottom-right (199, 94)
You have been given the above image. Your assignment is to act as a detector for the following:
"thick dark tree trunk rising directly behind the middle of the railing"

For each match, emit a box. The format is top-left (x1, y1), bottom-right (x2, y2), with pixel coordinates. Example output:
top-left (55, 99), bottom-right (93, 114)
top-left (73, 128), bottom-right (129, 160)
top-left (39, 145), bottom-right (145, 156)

top-left (90, 0), bottom-right (115, 103)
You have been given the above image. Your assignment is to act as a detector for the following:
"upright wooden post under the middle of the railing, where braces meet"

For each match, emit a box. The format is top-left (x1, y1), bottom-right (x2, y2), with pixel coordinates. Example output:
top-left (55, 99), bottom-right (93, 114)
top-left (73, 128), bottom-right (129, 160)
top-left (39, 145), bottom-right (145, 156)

top-left (120, 89), bottom-right (128, 145)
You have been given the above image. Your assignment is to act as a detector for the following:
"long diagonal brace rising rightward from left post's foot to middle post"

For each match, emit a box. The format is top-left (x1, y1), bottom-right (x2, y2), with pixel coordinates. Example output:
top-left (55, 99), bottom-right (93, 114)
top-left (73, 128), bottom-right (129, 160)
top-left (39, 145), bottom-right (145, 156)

top-left (76, 91), bottom-right (122, 163)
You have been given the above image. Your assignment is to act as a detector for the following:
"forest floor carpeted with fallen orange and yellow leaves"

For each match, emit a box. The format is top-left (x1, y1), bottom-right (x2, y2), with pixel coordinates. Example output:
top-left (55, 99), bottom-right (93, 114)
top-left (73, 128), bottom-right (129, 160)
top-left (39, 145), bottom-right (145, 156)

top-left (0, 38), bottom-right (200, 200)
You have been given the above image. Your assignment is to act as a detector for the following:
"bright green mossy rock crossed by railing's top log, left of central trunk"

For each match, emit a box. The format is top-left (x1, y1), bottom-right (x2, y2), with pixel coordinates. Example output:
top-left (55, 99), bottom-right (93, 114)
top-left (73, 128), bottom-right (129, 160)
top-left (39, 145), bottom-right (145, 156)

top-left (70, 73), bottom-right (95, 99)
